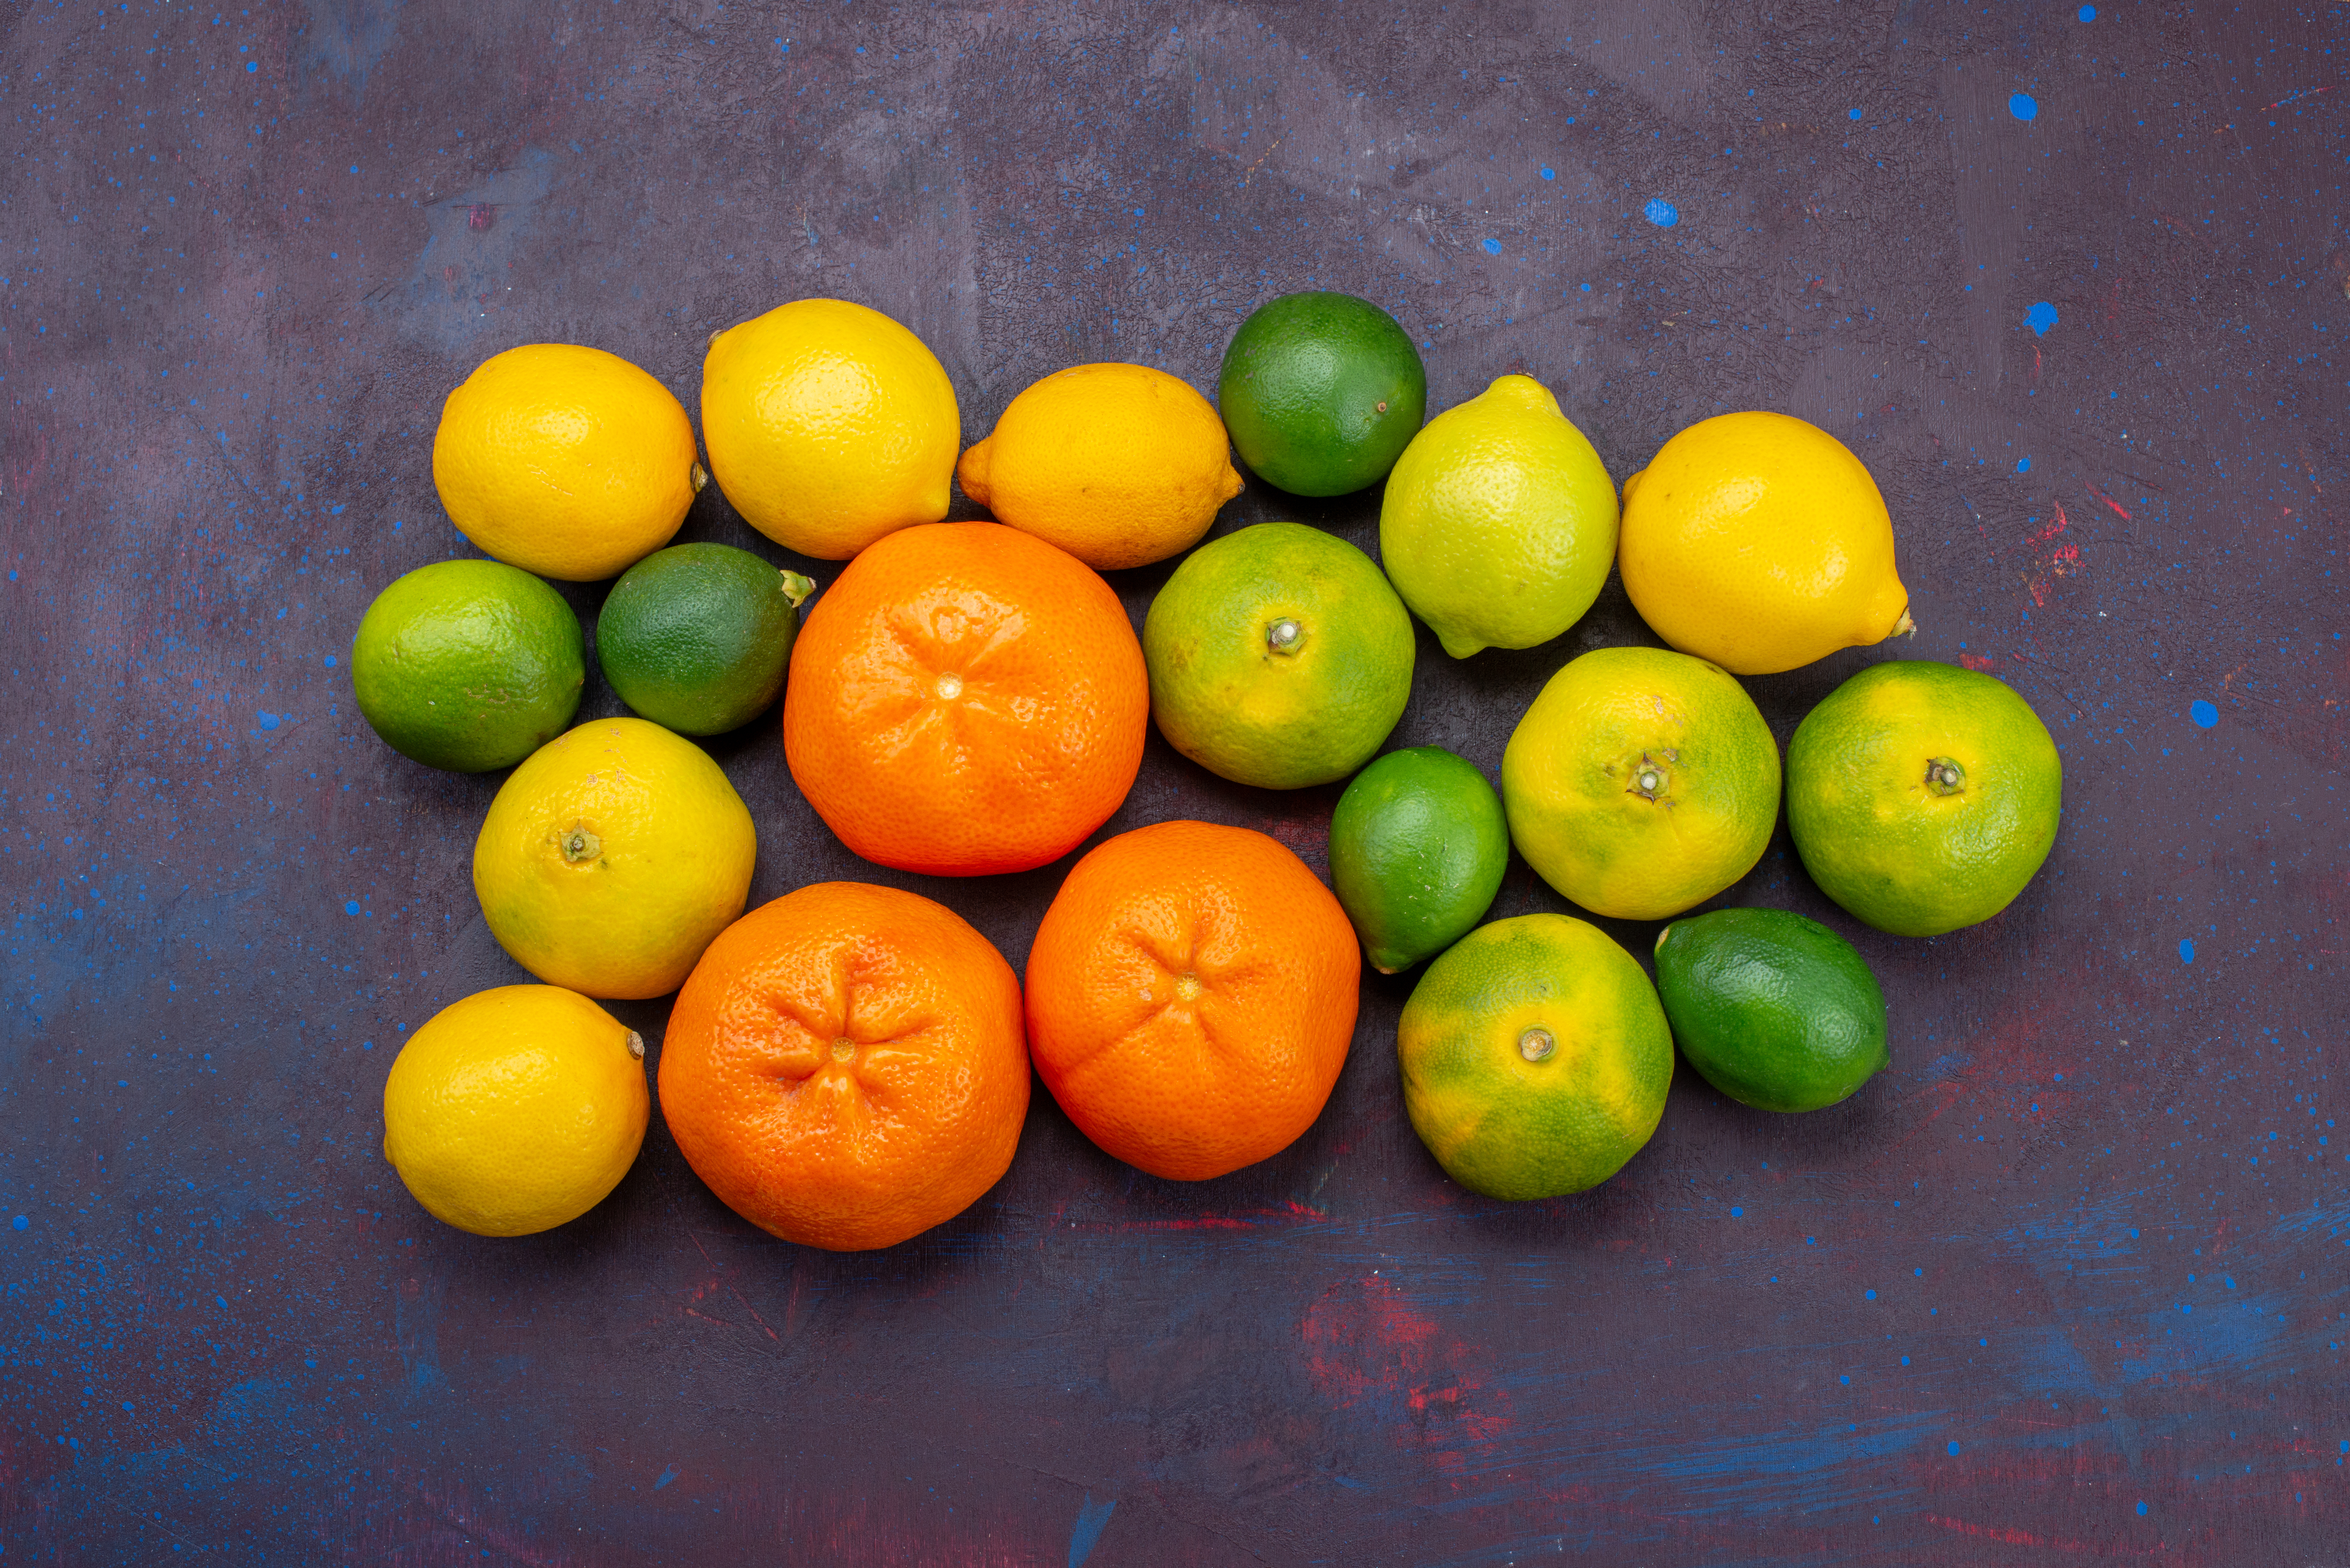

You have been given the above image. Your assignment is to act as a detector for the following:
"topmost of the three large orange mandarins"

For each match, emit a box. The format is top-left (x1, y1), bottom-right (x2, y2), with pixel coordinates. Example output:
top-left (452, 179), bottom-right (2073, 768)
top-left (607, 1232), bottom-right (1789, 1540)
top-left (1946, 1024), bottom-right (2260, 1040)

top-left (783, 522), bottom-right (1151, 877)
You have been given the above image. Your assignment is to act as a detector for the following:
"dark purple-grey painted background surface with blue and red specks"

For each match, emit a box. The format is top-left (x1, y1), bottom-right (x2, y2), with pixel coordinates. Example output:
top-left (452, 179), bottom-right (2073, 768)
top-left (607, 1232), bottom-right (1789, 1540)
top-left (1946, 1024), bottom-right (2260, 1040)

top-left (0, 0), bottom-right (2350, 1568)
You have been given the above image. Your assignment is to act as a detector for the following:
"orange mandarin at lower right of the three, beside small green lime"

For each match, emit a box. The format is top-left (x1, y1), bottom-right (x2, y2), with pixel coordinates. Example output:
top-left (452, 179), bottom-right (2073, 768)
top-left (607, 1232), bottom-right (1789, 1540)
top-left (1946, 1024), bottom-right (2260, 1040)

top-left (1027, 823), bottom-right (1363, 1180)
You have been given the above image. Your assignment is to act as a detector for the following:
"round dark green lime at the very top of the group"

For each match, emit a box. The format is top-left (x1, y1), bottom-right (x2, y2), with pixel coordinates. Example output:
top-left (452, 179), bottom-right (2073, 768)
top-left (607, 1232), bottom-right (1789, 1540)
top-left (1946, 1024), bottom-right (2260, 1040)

top-left (1215, 294), bottom-right (1429, 496)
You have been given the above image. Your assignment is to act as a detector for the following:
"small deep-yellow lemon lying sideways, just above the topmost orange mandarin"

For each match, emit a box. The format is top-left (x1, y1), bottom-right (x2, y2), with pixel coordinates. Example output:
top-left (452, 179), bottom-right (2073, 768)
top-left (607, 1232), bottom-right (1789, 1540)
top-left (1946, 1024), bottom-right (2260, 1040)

top-left (954, 364), bottom-right (1241, 571)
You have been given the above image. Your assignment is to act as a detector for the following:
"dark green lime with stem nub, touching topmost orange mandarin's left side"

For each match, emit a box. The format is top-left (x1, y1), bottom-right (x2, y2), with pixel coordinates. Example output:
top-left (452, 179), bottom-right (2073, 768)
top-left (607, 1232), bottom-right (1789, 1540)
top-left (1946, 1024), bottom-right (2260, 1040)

top-left (595, 546), bottom-right (815, 736)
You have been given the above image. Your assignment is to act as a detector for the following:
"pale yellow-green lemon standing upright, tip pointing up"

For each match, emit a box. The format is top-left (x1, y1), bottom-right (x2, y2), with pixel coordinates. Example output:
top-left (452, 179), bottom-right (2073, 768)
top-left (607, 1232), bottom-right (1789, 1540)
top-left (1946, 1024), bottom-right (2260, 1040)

top-left (1379, 376), bottom-right (1617, 658)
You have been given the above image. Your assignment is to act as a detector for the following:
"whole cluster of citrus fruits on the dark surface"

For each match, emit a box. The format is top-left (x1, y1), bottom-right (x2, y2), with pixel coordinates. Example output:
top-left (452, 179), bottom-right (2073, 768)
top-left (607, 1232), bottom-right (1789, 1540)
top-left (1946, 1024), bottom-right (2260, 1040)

top-left (352, 291), bottom-right (2061, 1248)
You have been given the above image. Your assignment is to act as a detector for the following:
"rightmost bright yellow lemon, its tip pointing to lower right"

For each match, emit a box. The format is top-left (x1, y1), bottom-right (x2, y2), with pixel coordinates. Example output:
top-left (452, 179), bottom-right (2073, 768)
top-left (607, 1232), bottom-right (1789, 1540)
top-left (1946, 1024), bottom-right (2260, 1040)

top-left (1617, 414), bottom-right (1915, 675)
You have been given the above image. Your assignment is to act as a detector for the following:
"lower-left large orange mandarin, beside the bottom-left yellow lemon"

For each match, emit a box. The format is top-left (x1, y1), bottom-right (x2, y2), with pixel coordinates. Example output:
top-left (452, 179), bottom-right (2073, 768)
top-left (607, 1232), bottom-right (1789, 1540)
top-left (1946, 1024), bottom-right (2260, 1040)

top-left (660, 882), bottom-right (1029, 1251)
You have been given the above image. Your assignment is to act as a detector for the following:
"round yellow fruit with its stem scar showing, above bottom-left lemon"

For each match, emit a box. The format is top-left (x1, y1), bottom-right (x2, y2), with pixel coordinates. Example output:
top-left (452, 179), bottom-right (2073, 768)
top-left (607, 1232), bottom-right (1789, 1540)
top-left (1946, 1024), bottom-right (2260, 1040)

top-left (472, 719), bottom-right (757, 999)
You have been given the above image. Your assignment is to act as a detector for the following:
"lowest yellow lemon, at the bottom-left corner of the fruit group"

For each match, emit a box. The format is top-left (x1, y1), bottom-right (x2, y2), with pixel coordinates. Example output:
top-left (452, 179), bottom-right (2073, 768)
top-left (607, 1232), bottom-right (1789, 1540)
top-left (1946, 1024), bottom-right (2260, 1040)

top-left (383, 985), bottom-right (653, 1237)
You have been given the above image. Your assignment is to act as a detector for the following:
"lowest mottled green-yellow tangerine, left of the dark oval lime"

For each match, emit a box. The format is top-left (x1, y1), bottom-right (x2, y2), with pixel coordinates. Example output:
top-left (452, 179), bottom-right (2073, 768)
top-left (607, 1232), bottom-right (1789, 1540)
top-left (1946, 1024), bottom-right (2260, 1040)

top-left (1396, 915), bottom-right (1673, 1199)
